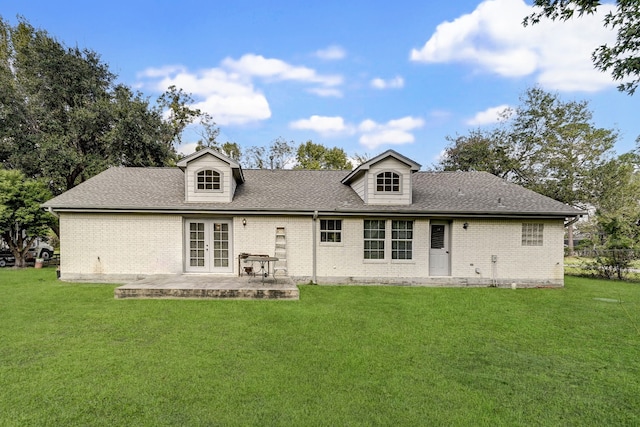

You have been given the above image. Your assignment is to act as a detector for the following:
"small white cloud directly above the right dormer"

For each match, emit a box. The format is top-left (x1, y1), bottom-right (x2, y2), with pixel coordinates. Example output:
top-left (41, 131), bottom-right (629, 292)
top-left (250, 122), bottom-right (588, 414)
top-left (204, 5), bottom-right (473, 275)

top-left (358, 116), bottom-right (424, 150)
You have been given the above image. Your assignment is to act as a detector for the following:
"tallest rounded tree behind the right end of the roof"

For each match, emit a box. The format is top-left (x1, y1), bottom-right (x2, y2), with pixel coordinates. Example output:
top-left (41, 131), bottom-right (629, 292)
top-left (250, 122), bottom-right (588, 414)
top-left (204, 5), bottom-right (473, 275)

top-left (506, 88), bottom-right (618, 208)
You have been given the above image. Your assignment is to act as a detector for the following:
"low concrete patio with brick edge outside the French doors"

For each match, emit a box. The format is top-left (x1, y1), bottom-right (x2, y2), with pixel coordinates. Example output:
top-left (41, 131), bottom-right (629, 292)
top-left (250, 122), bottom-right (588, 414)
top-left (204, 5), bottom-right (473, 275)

top-left (115, 274), bottom-right (300, 300)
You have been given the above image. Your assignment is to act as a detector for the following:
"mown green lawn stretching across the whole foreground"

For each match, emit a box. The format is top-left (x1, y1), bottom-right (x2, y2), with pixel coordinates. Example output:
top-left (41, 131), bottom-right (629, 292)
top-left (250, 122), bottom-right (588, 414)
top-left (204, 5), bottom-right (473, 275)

top-left (0, 268), bottom-right (640, 426)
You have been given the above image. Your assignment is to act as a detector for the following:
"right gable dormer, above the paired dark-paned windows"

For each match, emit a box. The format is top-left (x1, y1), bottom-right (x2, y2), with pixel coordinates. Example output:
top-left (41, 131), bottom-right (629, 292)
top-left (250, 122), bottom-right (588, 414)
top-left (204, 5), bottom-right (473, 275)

top-left (342, 150), bottom-right (420, 205)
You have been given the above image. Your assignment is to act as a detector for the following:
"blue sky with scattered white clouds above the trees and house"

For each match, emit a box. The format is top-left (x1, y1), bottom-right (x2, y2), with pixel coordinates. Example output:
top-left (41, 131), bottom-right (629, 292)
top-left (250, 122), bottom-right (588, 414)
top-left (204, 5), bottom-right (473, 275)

top-left (0, 0), bottom-right (640, 169)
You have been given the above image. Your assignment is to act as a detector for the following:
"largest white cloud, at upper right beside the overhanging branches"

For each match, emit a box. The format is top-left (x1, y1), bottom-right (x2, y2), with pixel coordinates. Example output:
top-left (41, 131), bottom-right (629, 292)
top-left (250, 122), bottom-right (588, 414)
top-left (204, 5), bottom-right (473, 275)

top-left (410, 0), bottom-right (615, 91)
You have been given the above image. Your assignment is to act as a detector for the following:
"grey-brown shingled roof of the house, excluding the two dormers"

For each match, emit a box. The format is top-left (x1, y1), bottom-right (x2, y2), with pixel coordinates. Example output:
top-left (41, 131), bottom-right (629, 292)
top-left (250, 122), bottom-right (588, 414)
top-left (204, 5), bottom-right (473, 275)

top-left (43, 168), bottom-right (583, 217)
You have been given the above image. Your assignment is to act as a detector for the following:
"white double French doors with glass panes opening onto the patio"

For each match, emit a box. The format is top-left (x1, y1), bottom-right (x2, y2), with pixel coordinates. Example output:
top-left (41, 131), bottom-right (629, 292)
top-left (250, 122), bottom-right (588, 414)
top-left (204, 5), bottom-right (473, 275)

top-left (185, 219), bottom-right (233, 273)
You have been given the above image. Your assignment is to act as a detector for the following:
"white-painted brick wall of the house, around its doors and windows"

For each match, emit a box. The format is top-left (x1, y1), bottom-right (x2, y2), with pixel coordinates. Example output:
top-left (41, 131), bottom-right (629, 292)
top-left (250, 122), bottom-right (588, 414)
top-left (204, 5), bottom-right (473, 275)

top-left (60, 213), bottom-right (564, 285)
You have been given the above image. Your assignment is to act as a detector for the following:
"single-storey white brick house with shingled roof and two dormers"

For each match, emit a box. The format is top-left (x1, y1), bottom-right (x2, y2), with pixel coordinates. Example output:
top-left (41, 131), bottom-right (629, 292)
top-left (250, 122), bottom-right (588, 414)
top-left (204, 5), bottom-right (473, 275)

top-left (44, 149), bottom-right (582, 286)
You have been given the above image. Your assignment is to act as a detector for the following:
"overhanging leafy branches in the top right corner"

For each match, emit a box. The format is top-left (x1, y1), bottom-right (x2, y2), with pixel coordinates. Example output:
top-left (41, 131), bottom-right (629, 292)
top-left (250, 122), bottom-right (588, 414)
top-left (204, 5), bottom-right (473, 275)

top-left (523, 0), bottom-right (640, 95)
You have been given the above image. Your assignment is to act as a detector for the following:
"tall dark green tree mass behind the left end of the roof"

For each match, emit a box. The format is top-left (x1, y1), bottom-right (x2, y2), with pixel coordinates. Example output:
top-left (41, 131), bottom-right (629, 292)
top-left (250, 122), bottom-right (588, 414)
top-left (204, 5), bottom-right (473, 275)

top-left (0, 18), bottom-right (200, 194)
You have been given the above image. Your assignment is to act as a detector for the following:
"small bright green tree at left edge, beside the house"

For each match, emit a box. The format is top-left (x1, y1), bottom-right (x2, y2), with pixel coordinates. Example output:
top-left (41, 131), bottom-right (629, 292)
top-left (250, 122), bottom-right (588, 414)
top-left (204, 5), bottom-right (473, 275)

top-left (0, 169), bottom-right (54, 267)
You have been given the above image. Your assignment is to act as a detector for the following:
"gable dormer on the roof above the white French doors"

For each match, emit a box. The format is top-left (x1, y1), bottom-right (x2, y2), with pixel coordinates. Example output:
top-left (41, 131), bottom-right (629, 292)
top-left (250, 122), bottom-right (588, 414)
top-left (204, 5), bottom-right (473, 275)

top-left (178, 148), bottom-right (244, 203)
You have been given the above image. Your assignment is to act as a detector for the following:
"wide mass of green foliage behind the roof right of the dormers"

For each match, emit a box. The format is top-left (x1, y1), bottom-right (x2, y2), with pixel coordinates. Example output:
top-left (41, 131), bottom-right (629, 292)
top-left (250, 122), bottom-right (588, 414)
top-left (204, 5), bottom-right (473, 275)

top-left (437, 88), bottom-right (618, 211)
